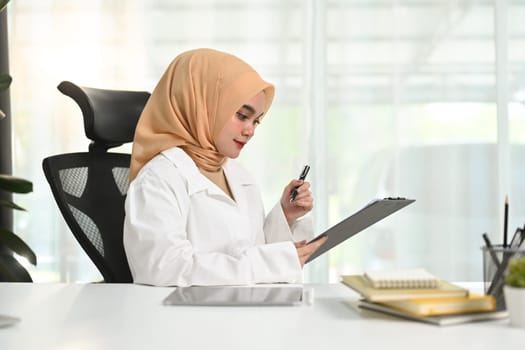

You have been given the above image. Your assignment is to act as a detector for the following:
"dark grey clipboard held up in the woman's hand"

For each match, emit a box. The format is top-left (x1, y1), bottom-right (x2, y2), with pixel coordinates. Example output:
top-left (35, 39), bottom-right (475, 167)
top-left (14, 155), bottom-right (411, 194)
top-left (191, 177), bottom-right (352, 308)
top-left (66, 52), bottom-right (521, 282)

top-left (305, 197), bottom-right (416, 263)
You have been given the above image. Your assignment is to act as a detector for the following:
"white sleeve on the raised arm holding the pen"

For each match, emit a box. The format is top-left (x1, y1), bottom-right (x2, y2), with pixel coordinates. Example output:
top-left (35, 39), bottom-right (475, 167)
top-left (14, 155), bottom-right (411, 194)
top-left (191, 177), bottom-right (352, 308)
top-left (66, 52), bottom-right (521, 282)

top-left (264, 202), bottom-right (313, 243)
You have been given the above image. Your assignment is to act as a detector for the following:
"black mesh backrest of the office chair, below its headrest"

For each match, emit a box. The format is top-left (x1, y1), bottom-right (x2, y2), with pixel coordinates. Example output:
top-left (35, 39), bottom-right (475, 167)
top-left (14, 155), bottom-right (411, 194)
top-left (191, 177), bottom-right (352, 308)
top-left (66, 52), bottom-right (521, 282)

top-left (43, 153), bottom-right (132, 283)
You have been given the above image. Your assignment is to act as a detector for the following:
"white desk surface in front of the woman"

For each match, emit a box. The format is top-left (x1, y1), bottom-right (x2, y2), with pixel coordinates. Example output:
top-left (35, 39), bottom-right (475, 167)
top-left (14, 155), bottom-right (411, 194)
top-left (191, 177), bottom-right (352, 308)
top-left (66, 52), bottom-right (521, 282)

top-left (0, 283), bottom-right (525, 350)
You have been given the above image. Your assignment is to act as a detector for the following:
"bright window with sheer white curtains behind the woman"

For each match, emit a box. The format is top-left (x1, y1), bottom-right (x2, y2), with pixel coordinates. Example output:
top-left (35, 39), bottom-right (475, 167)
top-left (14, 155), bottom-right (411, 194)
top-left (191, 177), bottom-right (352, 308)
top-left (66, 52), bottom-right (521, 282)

top-left (8, 0), bottom-right (525, 282)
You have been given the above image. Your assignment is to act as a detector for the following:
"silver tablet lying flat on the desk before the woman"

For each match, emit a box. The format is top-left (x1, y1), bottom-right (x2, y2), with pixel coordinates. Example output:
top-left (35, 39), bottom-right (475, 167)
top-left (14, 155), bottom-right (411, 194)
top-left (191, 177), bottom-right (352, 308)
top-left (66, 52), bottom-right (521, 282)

top-left (163, 285), bottom-right (303, 306)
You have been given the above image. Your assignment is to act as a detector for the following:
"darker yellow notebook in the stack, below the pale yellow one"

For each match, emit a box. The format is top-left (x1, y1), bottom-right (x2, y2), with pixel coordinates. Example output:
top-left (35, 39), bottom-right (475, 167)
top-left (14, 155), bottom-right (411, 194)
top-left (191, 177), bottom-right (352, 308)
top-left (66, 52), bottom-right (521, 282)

top-left (374, 294), bottom-right (496, 316)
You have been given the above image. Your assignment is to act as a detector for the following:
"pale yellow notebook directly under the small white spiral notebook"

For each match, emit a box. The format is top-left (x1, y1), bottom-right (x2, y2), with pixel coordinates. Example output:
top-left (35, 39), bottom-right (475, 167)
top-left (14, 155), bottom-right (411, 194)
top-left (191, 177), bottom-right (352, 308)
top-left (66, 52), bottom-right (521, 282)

top-left (341, 275), bottom-right (469, 302)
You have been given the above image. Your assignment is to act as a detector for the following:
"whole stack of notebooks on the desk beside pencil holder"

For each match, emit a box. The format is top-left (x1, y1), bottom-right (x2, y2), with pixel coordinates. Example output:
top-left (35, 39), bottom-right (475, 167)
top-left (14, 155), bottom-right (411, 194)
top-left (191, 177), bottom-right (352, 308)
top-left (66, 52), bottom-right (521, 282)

top-left (342, 269), bottom-right (507, 325)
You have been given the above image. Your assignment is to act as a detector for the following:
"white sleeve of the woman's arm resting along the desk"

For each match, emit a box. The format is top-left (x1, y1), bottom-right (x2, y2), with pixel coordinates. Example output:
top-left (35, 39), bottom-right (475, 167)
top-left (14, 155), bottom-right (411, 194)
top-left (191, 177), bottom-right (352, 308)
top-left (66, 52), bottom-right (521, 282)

top-left (124, 167), bottom-right (302, 286)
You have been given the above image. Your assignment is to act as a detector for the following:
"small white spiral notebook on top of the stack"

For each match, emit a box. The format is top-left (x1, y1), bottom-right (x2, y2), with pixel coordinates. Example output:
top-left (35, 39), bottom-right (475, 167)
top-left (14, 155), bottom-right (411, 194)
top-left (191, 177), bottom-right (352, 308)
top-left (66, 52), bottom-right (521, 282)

top-left (365, 268), bottom-right (439, 288)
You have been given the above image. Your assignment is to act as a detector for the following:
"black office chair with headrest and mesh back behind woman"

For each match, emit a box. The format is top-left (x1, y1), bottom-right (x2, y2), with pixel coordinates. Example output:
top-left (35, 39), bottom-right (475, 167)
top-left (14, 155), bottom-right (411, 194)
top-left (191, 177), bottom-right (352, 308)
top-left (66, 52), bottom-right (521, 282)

top-left (42, 81), bottom-right (150, 283)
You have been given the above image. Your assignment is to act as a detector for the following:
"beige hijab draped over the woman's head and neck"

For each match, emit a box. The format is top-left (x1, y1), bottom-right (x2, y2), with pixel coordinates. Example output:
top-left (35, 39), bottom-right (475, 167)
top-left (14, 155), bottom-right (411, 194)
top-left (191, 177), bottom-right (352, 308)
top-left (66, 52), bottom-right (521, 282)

top-left (130, 49), bottom-right (274, 181)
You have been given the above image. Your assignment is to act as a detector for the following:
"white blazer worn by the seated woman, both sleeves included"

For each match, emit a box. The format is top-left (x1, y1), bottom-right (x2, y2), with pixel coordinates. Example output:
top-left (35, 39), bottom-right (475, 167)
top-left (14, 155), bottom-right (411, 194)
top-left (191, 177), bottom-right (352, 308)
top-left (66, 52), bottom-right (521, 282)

top-left (124, 147), bottom-right (313, 286)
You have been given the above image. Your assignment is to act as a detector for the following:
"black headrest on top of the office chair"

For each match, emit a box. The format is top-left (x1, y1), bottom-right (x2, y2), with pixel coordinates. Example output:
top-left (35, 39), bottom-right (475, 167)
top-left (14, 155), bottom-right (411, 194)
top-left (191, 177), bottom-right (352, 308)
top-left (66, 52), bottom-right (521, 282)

top-left (58, 81), bottom-right (150, 152)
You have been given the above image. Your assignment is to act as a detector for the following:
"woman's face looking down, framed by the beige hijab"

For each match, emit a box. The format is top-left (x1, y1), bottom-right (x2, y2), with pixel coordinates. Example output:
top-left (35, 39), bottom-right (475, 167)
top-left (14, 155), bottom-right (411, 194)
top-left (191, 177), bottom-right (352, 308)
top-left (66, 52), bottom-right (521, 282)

top-left (215, 91), bottom-right (266, 158)
